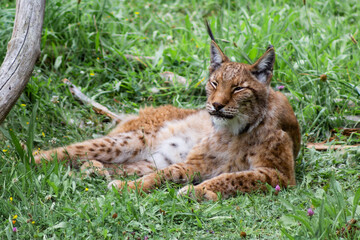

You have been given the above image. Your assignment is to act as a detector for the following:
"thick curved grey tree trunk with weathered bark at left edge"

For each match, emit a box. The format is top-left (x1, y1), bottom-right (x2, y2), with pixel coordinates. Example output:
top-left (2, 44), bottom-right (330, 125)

top-left (0, 0), bottom-right (45, 123)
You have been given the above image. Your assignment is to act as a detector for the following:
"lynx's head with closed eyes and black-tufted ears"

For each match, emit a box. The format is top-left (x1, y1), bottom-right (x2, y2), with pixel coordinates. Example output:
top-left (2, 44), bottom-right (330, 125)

top-left (206, 20), bottom-right (275, 135)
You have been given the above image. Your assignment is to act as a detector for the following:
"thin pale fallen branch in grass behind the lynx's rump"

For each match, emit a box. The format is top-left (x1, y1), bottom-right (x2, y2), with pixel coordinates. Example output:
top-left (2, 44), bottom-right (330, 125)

top-left (63, 78), bottom-right (123, 122)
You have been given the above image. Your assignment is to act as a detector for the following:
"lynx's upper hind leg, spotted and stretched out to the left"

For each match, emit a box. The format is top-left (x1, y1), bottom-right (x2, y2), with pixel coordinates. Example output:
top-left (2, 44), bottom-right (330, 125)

top-left (34, 131), bottom-right (146, 165)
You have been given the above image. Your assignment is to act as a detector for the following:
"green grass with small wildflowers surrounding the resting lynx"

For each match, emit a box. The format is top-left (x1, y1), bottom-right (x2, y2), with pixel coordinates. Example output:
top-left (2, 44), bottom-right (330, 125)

top-left (0, 0), bottom-right (360, 239)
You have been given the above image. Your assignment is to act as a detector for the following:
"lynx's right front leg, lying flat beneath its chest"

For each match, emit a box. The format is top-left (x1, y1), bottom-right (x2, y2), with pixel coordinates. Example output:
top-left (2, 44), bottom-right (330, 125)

top-left (178, 167), bottom-right (289, 201)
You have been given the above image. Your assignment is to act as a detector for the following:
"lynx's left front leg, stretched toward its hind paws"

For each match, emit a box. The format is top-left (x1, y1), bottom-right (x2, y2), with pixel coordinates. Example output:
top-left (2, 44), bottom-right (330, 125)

top-left (108, 163), bottom-right (195, 192)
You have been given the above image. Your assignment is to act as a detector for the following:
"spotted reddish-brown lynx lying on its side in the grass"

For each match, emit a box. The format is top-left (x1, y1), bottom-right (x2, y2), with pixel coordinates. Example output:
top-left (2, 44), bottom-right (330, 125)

top-left (35, 24), bottom-right (300, 200)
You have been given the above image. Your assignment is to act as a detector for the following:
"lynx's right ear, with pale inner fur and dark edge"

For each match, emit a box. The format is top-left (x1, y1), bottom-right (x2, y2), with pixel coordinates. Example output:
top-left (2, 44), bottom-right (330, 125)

top-left (251, 45), bottom-right (275, 84)
